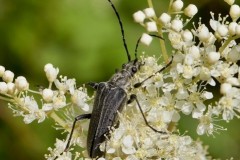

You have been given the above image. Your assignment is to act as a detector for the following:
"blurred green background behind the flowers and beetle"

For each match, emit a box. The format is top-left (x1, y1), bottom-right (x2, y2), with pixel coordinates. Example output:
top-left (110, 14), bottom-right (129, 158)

top-left (0, 0), bottom-right (240, 160)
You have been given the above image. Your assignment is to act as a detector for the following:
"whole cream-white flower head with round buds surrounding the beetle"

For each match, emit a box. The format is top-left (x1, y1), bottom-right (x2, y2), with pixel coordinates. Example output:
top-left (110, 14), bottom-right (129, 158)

top-left (0, 0), bottom-right (240, 160)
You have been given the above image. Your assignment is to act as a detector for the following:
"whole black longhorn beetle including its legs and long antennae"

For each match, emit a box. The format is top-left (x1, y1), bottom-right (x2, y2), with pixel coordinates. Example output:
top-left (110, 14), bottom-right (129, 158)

top-left (55, 0), bottom-right (172, 159)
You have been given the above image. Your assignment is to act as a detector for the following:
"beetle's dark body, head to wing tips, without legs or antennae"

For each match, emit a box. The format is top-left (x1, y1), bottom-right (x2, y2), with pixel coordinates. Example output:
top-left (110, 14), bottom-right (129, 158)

top-left (87, 59), bottom-right (141, 158)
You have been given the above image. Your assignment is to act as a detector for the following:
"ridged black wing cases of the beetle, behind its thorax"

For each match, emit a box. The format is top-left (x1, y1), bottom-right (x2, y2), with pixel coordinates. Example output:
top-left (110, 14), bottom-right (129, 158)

top-left (87, 82), bottom-right (127, 158)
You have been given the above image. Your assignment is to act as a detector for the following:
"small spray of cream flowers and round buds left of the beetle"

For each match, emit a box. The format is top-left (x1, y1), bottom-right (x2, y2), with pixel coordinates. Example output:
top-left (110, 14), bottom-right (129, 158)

top-left (0, 64), bottom-right (90, 124)
